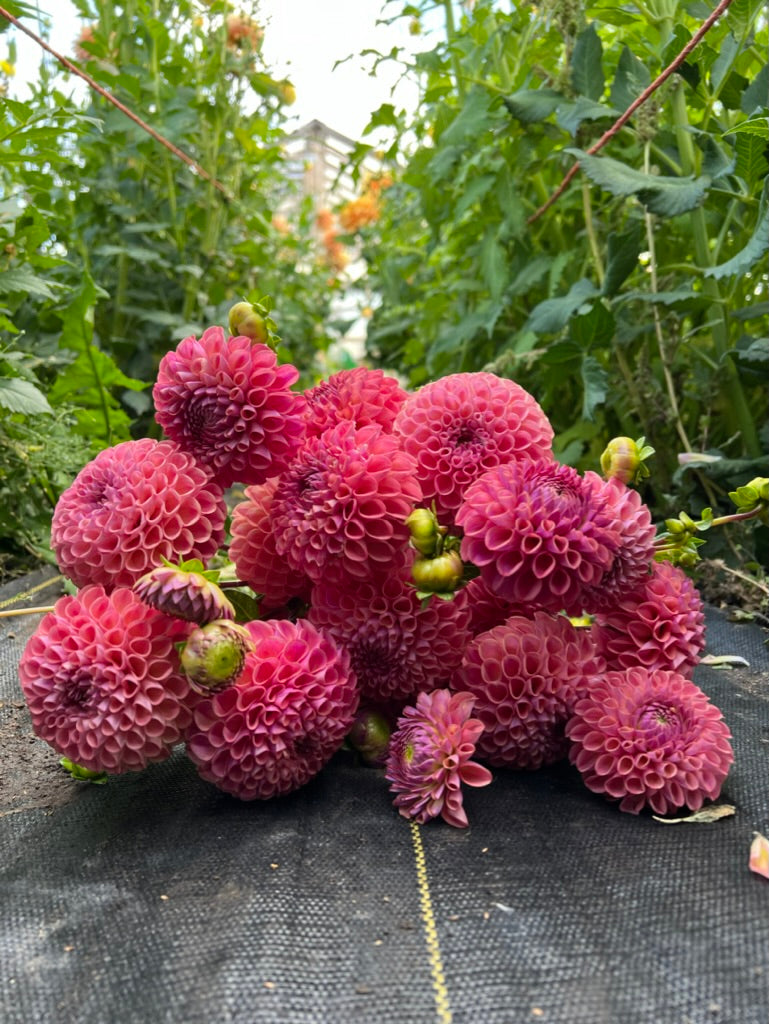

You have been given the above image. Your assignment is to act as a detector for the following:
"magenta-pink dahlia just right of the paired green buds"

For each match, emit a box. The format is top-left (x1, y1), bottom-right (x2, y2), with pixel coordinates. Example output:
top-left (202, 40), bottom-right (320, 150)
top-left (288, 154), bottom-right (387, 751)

top-left (457, 460), bottom-right (620, 614)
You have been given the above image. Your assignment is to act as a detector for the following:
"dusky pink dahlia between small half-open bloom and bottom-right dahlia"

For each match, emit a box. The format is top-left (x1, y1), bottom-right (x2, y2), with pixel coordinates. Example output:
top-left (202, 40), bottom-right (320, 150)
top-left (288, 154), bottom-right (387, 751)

top-left (452, 611), bottom-right (603, 769)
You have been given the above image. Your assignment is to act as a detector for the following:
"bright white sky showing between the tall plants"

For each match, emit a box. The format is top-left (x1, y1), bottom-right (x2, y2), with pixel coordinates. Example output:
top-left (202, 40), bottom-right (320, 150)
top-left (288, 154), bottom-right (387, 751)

top-left (7, 0), bottom-right (429, 142)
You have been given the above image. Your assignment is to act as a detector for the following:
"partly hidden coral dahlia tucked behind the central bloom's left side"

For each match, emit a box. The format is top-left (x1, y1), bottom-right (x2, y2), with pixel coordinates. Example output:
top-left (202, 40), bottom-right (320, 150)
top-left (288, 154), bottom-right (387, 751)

top-left (229, 479), bottom-right (311, 609)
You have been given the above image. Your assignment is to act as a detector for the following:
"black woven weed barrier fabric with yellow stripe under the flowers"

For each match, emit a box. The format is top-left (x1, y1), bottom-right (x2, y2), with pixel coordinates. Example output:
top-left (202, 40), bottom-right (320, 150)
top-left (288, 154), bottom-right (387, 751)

top-left (0, 572), bottom-right (769, 1024)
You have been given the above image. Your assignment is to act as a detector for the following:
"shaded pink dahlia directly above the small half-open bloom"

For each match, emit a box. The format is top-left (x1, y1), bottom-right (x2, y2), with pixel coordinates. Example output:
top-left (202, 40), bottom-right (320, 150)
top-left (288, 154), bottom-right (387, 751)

top-left (309, 573), bottom-right (470, 705)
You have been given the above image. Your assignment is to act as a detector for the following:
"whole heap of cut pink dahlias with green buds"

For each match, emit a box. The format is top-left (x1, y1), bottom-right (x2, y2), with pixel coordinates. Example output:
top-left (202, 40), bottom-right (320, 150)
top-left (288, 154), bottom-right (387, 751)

top-left (19, 303), bottom-right (733, 827)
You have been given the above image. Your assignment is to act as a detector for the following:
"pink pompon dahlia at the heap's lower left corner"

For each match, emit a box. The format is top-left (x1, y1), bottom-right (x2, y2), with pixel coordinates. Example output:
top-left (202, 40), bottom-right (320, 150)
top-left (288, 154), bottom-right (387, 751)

top-left (18, 586), bottom-right (196, 774)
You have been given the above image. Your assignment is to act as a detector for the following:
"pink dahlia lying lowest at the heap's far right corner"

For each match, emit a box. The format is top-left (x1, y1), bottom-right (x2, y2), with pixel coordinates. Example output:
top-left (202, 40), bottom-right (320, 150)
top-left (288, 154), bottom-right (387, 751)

top-left (566, 668), bottom-right (734, 814)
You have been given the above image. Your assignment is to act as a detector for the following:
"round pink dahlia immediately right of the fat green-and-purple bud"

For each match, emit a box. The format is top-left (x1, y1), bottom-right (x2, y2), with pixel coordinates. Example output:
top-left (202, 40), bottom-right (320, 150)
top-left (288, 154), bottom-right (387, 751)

top-left (187, 620), bottom-right (358, 800)
